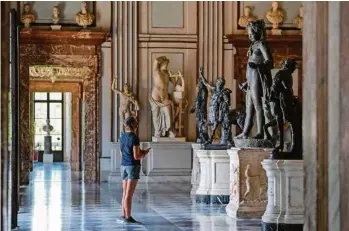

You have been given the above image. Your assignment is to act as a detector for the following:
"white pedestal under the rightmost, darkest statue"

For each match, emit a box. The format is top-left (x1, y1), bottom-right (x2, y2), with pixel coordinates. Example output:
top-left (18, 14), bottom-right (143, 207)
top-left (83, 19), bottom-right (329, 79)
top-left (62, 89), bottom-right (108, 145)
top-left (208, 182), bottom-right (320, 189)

top-left (262, 160), bottom-right (304, 231)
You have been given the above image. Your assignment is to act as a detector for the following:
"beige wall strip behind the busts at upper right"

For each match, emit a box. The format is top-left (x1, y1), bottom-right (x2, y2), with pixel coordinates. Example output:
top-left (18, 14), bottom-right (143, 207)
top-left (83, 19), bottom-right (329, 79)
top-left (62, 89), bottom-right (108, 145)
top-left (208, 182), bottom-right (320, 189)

top-left (236, 1), bottom-right (302, 30)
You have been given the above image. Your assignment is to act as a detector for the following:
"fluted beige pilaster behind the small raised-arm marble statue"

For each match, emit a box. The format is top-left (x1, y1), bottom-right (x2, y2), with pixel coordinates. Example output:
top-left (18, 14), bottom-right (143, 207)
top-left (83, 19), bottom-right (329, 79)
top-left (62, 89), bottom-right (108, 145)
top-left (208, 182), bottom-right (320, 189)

top-left (110, 2), bottom-right (138, 142)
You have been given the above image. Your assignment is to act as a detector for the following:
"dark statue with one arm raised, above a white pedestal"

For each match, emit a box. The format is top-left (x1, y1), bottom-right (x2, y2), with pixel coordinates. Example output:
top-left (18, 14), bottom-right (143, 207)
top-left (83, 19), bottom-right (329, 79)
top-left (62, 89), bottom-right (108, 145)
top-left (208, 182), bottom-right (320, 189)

top-left (199, 67), bottom-right (232, 145)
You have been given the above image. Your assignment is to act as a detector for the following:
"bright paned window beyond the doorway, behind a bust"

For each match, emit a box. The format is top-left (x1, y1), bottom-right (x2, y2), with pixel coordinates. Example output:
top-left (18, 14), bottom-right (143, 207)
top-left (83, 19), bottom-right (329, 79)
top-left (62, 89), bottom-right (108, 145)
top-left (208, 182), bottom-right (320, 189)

top-left (34, 92), bottom-right (63, 151)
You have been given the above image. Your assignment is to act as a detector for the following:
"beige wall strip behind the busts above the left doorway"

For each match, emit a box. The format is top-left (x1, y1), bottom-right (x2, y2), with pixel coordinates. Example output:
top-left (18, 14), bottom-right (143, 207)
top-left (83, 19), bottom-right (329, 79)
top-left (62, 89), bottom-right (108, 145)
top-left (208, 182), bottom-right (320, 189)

top-left (18, 1), bottom-right (96, 27)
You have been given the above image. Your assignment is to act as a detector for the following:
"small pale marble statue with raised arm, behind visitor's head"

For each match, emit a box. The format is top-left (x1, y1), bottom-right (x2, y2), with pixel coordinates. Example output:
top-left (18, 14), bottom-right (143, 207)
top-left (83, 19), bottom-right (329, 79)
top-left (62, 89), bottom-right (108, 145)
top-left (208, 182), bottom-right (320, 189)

top-left (112, 78), bottom-right (139, 132)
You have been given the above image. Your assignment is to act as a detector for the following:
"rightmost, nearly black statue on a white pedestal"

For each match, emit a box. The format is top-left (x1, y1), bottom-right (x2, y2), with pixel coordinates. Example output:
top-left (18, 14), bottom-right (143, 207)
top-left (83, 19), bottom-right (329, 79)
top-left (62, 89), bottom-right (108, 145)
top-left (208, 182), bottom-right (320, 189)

top-left (264, 59), bottom-right (302, 159)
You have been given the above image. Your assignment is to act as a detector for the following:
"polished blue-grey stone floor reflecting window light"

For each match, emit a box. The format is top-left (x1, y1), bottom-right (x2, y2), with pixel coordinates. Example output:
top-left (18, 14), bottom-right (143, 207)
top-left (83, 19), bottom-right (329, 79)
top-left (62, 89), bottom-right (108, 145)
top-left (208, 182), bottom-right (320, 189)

top-left (16, 164), bottom-right (261, 231)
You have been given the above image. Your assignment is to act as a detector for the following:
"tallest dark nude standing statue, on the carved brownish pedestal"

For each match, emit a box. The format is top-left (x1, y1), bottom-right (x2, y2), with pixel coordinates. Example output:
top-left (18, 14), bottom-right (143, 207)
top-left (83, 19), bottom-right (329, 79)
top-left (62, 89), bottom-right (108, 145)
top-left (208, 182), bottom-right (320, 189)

top-left (235, 20), bottom-right (274, 139)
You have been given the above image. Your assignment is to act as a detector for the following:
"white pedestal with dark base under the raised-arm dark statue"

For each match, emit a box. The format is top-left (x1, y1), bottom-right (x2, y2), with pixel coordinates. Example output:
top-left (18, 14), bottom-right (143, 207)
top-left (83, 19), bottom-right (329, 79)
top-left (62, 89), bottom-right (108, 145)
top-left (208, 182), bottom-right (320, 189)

top-left (195, 150), bottom-right (229, 204)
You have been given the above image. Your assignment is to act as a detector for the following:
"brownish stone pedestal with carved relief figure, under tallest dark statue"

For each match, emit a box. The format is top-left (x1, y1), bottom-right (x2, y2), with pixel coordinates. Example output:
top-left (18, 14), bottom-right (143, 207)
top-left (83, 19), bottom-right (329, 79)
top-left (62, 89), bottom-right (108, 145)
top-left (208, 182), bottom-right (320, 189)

top-left (226, 148), bottom-right (272, 218)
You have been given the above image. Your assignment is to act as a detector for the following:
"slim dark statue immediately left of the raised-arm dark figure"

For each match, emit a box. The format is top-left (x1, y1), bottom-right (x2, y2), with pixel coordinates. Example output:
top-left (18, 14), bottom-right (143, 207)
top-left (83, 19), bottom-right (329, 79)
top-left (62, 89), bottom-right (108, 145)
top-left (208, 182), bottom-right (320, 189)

top-left (190, 75), bottom-right (209, 144)
